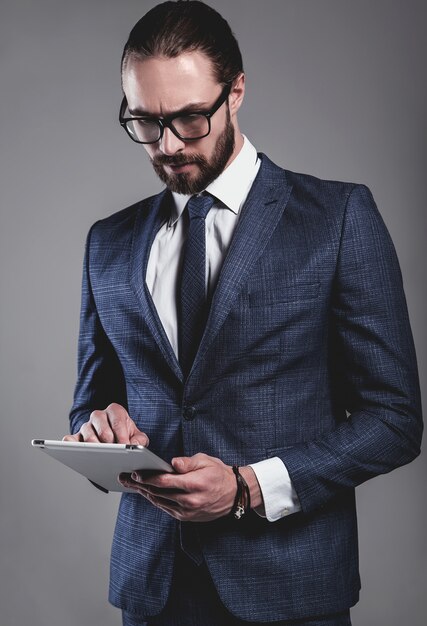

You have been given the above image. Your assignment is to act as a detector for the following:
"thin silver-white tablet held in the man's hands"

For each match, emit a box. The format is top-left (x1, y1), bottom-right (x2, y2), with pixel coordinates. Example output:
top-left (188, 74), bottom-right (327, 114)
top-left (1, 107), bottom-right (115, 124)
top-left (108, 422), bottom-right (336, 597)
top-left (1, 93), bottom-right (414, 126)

top-left (31, 439), bottom-right (174, 493)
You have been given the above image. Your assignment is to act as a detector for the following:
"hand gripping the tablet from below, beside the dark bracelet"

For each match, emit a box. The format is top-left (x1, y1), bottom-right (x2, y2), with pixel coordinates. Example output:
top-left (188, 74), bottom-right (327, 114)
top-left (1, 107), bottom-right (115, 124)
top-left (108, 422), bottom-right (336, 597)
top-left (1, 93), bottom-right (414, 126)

top-left (120, 453), bottom-right (261, 522)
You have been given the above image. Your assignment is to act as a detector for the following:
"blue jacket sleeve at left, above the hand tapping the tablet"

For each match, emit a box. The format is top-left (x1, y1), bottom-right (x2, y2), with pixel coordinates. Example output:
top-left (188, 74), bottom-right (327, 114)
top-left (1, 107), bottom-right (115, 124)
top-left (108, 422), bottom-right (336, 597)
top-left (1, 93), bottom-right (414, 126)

top-left (70, 224), bottom-right (127, 434)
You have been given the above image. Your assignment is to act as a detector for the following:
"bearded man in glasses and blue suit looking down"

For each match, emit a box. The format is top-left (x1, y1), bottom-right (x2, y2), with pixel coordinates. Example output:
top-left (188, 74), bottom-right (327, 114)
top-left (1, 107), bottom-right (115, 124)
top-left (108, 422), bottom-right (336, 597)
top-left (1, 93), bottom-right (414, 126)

top-left (67, 1), bottom-right (422, 626)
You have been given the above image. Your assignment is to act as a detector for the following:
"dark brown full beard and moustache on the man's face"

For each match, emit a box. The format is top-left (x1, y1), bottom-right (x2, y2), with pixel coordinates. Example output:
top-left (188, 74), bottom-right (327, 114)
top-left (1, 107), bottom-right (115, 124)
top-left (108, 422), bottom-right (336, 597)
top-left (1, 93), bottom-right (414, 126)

top-left (151, 107), bottom-right (235, 196)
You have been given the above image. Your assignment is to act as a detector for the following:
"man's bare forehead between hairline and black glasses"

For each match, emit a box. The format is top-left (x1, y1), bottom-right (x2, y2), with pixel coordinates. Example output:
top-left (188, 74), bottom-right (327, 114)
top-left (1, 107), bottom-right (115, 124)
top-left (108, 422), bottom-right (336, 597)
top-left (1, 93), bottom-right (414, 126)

top-left (123, 51), bottom-right (218, 115)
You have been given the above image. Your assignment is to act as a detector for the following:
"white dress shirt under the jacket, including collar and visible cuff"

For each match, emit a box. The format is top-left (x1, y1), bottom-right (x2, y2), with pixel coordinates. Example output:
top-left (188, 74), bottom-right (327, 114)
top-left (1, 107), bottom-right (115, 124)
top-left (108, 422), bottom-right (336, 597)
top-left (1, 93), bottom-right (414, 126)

top-left (146, 137), bottom-right (301, 522)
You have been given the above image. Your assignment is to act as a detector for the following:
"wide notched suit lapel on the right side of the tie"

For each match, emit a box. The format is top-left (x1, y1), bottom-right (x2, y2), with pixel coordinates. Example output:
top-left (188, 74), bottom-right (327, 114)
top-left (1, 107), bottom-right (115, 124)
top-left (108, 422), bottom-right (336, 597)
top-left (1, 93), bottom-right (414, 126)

top-left (194, 154), bottom-right (292, 367)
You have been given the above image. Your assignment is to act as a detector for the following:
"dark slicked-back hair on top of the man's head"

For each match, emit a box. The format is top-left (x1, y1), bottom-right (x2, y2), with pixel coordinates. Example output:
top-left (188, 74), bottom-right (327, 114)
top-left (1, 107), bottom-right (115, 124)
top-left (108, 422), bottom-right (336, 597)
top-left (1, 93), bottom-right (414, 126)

top-left (122, 0), bottom-right (243, 83)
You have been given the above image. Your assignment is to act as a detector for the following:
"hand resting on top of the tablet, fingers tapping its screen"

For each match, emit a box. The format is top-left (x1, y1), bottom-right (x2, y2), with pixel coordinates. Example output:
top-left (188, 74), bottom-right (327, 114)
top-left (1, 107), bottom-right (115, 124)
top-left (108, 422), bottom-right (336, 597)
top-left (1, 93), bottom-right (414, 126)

top-left (63, 403), bottom-right (149, 446)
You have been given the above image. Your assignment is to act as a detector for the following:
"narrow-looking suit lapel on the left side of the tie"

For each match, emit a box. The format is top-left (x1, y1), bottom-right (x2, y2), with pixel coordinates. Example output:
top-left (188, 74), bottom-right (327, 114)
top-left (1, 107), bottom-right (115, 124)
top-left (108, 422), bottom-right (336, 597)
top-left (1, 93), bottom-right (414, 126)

top-left (130, 190), bottom-right (183, 380)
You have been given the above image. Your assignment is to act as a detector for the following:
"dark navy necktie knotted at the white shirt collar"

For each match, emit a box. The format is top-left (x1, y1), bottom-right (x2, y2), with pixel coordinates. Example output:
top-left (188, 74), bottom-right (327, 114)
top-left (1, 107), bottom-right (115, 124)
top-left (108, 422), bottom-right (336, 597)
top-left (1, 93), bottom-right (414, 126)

top-left (179, 194), bottom-right (214, 377)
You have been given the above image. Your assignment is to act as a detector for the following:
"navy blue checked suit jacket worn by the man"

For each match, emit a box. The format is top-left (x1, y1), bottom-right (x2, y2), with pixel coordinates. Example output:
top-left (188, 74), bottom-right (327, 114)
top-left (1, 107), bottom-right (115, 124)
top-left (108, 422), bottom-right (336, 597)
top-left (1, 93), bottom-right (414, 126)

top-left (71, 155), bottom-right (422, 621)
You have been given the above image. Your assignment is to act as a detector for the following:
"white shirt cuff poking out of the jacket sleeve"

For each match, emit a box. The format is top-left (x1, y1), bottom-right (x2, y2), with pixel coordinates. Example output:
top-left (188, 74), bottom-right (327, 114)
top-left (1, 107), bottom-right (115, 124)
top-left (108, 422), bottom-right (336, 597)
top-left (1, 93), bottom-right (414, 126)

top-left (249, 456), bottom-right (301, 522)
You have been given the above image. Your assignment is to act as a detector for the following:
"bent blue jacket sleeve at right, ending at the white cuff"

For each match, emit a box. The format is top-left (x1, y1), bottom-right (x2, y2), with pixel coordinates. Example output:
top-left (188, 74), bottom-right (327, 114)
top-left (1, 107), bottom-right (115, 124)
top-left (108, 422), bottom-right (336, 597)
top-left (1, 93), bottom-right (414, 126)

top-left (281, 185), bottom-right (422, 512)
